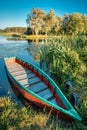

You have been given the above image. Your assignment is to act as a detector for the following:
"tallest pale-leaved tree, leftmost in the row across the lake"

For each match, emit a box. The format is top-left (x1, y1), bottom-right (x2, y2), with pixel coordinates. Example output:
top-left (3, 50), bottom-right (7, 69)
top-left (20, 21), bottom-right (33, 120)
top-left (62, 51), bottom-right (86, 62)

top-left (26, 8), bottom-right (46, 35)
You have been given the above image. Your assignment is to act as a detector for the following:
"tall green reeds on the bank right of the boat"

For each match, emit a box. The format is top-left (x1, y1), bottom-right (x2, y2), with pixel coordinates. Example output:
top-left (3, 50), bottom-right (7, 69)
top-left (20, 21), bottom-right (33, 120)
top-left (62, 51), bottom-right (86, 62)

top-left (41, 36), bottom-right (87, 126)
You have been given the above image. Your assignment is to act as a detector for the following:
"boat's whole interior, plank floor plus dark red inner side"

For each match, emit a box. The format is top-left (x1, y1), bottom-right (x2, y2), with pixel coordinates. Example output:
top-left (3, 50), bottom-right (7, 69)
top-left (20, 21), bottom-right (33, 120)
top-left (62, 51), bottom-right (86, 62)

top-left (6, 60), bottom-right (66, 109)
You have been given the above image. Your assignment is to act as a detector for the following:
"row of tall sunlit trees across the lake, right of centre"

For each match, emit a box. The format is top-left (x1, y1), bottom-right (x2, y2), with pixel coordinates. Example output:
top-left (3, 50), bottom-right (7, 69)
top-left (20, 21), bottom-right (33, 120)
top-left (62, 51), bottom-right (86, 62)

top-left (26, 8), bottom-right (87, 35)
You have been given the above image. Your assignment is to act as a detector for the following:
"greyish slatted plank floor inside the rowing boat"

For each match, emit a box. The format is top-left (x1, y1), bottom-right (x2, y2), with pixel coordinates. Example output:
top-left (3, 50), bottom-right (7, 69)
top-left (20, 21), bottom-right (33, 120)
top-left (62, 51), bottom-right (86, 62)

top-left (9, 61), bottom-right (56, 103)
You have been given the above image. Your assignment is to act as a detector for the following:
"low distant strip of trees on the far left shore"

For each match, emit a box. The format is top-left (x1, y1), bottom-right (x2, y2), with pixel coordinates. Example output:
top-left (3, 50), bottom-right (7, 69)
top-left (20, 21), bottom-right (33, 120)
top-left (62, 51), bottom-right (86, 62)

top-left (0, 27), bottom-right (27, 33)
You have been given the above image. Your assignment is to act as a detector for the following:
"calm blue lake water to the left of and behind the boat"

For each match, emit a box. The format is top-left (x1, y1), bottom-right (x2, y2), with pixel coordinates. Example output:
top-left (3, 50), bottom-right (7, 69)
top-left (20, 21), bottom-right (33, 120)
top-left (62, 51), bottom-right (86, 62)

top-left (0, 36), bottom-right (42, 102)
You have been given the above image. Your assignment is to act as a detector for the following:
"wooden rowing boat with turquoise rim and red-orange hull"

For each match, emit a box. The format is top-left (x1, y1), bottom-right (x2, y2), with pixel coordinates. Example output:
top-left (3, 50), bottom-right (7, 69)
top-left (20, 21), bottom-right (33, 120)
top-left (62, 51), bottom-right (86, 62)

top-left (4, 57), bottom-right (81, 121)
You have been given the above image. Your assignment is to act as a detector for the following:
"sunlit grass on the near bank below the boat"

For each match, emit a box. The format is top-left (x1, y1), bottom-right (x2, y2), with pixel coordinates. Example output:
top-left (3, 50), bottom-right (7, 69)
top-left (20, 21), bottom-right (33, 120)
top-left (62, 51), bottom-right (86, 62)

top-left (0, 97), bottom-right (78, 130)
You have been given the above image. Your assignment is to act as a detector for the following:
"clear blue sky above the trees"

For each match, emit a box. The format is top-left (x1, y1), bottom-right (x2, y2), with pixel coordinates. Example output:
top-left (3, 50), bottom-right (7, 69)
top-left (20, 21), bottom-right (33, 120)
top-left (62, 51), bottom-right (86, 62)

top-left (0, 0), bottom-right (87, 29)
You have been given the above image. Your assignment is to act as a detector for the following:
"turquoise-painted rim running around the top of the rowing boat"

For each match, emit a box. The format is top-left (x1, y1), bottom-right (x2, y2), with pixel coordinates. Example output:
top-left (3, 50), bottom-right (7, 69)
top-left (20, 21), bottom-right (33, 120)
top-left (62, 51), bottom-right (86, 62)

top-left (4, 57), bottom-right (82, 121)
